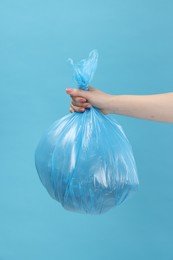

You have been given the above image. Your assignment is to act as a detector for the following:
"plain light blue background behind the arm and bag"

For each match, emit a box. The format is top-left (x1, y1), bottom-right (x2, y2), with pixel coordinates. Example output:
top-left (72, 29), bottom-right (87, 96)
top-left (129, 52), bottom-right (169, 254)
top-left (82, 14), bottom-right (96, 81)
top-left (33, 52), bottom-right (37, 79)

top-left (0, 0), bottom-right (173, 260)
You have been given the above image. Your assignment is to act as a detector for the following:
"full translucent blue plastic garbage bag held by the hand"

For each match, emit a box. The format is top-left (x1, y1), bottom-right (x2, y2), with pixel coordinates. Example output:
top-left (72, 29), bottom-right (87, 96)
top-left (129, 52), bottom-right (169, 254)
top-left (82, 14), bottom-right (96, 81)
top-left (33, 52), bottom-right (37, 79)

top-left (35, 50), bottom-right (138, 214)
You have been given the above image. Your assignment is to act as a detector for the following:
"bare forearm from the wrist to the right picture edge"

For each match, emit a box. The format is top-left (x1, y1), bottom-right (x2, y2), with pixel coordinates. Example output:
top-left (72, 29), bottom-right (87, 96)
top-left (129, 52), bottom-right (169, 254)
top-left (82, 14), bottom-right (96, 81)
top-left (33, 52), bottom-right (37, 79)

top-left (109, 92), bottom-right (173, 123)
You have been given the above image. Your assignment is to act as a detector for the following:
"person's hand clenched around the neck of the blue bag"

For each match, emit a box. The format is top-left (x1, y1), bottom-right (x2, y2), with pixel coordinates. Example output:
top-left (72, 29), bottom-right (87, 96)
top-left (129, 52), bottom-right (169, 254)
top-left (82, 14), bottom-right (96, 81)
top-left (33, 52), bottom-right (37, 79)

top-left (66, 87), bottom-right (111, 114)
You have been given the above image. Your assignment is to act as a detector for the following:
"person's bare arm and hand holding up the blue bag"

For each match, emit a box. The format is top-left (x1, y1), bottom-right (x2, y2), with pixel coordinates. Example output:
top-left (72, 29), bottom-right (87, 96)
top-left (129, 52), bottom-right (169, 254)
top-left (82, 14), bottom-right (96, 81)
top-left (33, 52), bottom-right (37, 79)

top-left (66, 87), bottom-right (173, 123)
